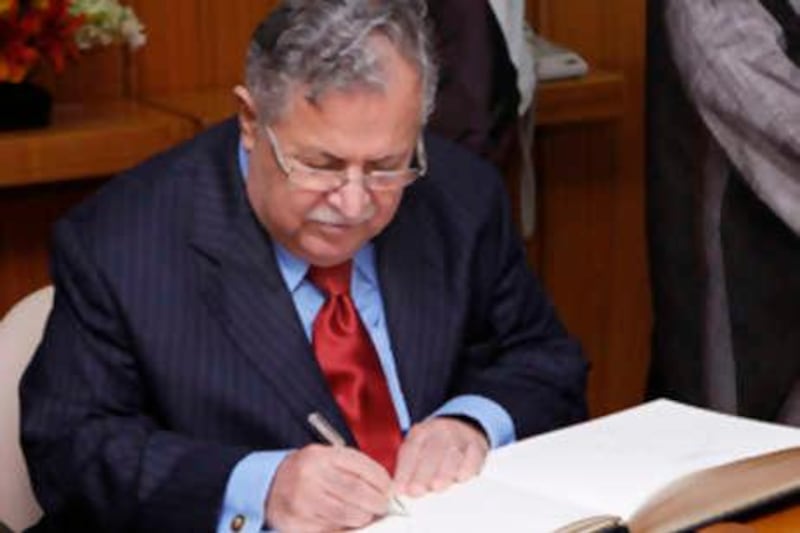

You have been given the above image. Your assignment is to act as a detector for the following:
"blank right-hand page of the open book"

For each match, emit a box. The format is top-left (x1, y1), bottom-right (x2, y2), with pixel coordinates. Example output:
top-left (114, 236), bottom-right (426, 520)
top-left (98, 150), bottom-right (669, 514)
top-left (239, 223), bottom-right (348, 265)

top-left (481, 400), bottom-right (800, 518)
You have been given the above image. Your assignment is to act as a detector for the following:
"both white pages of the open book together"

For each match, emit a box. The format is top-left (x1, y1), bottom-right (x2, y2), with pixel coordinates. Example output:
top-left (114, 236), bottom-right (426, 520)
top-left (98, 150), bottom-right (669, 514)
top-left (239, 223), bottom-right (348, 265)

top-left (365, 400), bottom-right (800, 533)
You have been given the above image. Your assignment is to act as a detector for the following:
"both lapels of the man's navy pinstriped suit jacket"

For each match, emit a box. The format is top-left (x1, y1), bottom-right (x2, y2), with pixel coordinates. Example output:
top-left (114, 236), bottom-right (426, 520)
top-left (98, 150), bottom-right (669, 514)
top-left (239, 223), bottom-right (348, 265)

top-left (184, 124), bottom-right (457, 436)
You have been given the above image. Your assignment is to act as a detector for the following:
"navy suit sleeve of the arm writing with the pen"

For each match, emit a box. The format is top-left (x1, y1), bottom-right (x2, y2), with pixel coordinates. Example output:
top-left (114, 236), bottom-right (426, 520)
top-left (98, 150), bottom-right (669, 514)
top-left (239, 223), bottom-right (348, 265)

top-left (20, 218), bottom-right (250, 531)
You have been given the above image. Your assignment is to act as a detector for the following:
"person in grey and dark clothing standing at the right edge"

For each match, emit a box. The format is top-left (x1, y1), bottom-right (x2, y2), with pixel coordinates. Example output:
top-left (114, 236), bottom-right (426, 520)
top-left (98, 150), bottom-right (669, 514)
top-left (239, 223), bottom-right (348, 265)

top-left (647, 0), bottom-right (800, 425)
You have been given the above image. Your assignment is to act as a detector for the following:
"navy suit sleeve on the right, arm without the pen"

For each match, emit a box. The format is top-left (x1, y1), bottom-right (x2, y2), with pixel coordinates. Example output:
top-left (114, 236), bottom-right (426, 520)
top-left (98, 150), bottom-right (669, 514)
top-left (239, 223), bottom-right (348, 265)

top-left (455, 167), bottom-right (587, 438)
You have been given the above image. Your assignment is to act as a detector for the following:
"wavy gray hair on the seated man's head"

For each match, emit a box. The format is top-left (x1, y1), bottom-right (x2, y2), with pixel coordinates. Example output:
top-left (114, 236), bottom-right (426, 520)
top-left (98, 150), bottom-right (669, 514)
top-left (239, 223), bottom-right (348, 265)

top-left (245, 0), bottom-right (438, 123)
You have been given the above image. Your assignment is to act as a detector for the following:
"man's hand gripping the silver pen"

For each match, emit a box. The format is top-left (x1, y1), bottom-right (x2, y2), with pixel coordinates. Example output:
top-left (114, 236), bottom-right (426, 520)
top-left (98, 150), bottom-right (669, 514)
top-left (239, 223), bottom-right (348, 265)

top-left (266, 444), bottom-right (391, 531)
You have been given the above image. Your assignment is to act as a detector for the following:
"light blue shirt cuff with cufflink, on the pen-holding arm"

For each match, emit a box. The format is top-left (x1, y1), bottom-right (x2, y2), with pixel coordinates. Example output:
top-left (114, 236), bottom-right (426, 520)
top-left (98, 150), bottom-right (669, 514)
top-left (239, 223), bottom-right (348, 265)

top-left (217, 450), bottom-right (290, 533)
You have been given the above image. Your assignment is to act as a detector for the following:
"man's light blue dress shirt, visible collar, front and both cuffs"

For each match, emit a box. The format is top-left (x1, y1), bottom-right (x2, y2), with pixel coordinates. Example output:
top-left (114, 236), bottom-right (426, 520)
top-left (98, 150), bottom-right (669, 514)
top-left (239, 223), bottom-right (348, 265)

top-left (217, 141), bottom-right (516, 533)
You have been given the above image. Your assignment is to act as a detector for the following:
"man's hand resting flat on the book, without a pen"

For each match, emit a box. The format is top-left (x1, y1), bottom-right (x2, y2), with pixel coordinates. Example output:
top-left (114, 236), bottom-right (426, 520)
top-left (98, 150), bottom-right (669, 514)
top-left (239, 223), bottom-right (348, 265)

top-left (394, 417), bottom-right (489, 497)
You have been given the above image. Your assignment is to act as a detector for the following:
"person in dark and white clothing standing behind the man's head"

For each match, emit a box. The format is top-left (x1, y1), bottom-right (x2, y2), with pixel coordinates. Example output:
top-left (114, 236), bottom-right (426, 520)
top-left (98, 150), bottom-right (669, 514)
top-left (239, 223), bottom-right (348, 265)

top-left (428, 0), bottom-right (536, 238)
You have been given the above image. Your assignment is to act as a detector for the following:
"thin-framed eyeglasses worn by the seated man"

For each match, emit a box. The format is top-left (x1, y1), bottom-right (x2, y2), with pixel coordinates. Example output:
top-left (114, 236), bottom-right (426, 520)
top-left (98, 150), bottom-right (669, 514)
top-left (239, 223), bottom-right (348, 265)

top-left (264, 126), bottom-right (428, 192)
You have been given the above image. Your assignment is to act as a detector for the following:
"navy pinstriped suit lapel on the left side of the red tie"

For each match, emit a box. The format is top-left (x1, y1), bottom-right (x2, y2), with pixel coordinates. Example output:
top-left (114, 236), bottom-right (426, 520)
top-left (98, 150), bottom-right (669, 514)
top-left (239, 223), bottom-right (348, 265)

top-left (192, 131), bottom-right (352, 442)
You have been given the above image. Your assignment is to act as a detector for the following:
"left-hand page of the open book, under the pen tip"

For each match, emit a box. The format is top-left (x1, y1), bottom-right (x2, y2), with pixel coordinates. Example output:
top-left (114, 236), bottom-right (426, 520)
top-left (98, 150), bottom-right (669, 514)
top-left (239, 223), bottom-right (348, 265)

top-left (363, 477), bottom-right (597, 533)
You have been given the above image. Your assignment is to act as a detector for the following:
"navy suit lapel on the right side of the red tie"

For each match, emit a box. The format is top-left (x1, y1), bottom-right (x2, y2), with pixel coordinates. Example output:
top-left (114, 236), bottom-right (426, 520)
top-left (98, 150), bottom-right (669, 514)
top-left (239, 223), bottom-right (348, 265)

top-left (376, 189), bottom-right (454, 422)
